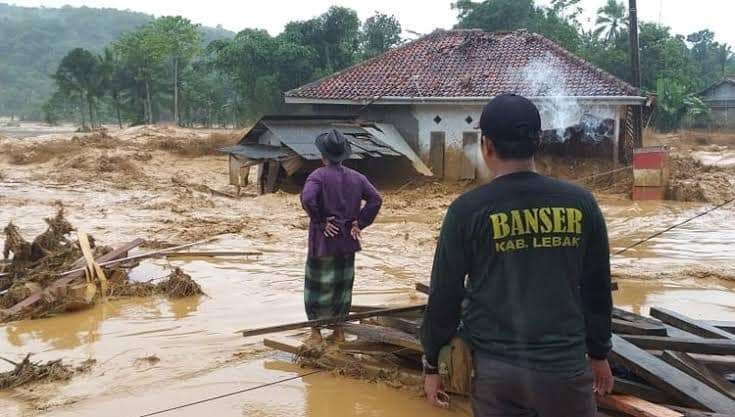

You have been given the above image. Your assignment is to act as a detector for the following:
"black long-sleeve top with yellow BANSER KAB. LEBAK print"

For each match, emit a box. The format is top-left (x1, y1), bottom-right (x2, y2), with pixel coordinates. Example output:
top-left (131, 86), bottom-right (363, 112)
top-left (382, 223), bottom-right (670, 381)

top-left (421, 172), bottom-right (612, 373)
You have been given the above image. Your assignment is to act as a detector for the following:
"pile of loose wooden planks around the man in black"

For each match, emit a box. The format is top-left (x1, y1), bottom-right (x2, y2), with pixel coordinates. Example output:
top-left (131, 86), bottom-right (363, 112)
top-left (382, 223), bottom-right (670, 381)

top-left (258, 284), bottom-right (735, 417)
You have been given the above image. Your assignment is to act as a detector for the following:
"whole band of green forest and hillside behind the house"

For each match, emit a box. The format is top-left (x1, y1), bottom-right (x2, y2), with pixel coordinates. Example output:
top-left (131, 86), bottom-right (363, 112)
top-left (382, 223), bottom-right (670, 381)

top-left (0, 0), bottom-right (735, 129)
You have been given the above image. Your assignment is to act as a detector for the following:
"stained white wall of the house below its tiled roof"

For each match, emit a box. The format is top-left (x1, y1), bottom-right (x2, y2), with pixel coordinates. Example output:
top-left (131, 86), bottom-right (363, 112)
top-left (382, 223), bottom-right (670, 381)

top-left (412, 102), bottom-right (624, 179)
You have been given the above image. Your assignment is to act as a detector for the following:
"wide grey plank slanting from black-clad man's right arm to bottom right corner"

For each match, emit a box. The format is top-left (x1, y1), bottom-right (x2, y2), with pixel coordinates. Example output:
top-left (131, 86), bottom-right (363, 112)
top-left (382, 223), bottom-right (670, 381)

top-left (611, 335), bottom-right (735, 413)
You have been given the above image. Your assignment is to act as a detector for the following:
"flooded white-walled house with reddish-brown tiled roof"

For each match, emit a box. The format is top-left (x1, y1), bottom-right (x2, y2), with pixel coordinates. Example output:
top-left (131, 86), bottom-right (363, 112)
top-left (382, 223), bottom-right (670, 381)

top-left (285, 30), bottom-right (645, 179)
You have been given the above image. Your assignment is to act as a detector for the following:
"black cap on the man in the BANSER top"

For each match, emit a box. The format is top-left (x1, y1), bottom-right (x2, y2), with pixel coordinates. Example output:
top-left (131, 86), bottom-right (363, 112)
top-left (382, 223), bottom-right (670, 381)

top-left (480, 94), bottom-right (541, 141)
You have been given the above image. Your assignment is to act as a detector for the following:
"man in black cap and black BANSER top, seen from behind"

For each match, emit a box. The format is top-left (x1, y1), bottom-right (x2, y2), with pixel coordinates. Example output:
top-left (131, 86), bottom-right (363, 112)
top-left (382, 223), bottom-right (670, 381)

top-left (421, 95), bottom-right (613, 417)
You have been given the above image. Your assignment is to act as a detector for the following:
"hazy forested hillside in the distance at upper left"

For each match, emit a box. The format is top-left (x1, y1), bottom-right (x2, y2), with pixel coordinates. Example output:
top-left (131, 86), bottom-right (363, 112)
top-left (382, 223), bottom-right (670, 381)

top-left (0, 3), bottom-right (234, 120)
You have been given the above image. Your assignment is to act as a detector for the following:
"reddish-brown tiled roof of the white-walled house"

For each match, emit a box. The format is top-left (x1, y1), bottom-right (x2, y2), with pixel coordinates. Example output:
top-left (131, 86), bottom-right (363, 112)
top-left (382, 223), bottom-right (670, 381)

top-left (286, 29), bottom-right (640, 102)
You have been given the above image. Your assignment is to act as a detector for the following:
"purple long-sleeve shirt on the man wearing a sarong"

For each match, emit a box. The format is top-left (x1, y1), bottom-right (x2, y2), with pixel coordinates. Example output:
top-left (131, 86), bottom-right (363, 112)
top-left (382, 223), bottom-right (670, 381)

top-left (301, 165), bottom-right (383, 257)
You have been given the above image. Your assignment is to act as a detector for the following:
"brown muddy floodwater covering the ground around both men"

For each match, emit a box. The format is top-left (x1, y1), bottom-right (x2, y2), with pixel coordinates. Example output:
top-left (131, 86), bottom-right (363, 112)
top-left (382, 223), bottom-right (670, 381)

top-left (0, 125), bottom-right (735, 417)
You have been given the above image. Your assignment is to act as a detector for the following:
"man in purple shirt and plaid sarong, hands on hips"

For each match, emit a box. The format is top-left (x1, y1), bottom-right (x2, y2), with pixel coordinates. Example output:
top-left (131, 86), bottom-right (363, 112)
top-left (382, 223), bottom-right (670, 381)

top-left (301, 130), bottom-right (383, 343)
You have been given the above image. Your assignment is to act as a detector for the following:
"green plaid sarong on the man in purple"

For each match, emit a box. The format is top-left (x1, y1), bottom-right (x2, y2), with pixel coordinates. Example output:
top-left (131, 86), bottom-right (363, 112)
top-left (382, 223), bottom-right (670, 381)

top-left (304, 254), bottom-right (355, 320)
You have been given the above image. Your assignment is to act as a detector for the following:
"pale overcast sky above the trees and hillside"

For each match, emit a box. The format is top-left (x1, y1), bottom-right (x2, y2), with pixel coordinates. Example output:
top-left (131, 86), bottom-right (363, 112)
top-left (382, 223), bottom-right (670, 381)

top-left (7, 0), bottom-right (735, 47)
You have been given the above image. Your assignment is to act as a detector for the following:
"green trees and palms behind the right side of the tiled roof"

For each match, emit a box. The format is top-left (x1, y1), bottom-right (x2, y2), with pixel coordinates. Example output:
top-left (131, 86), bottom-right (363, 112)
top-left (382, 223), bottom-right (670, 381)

top-left (453, 0), bottom-right (735, 129)
